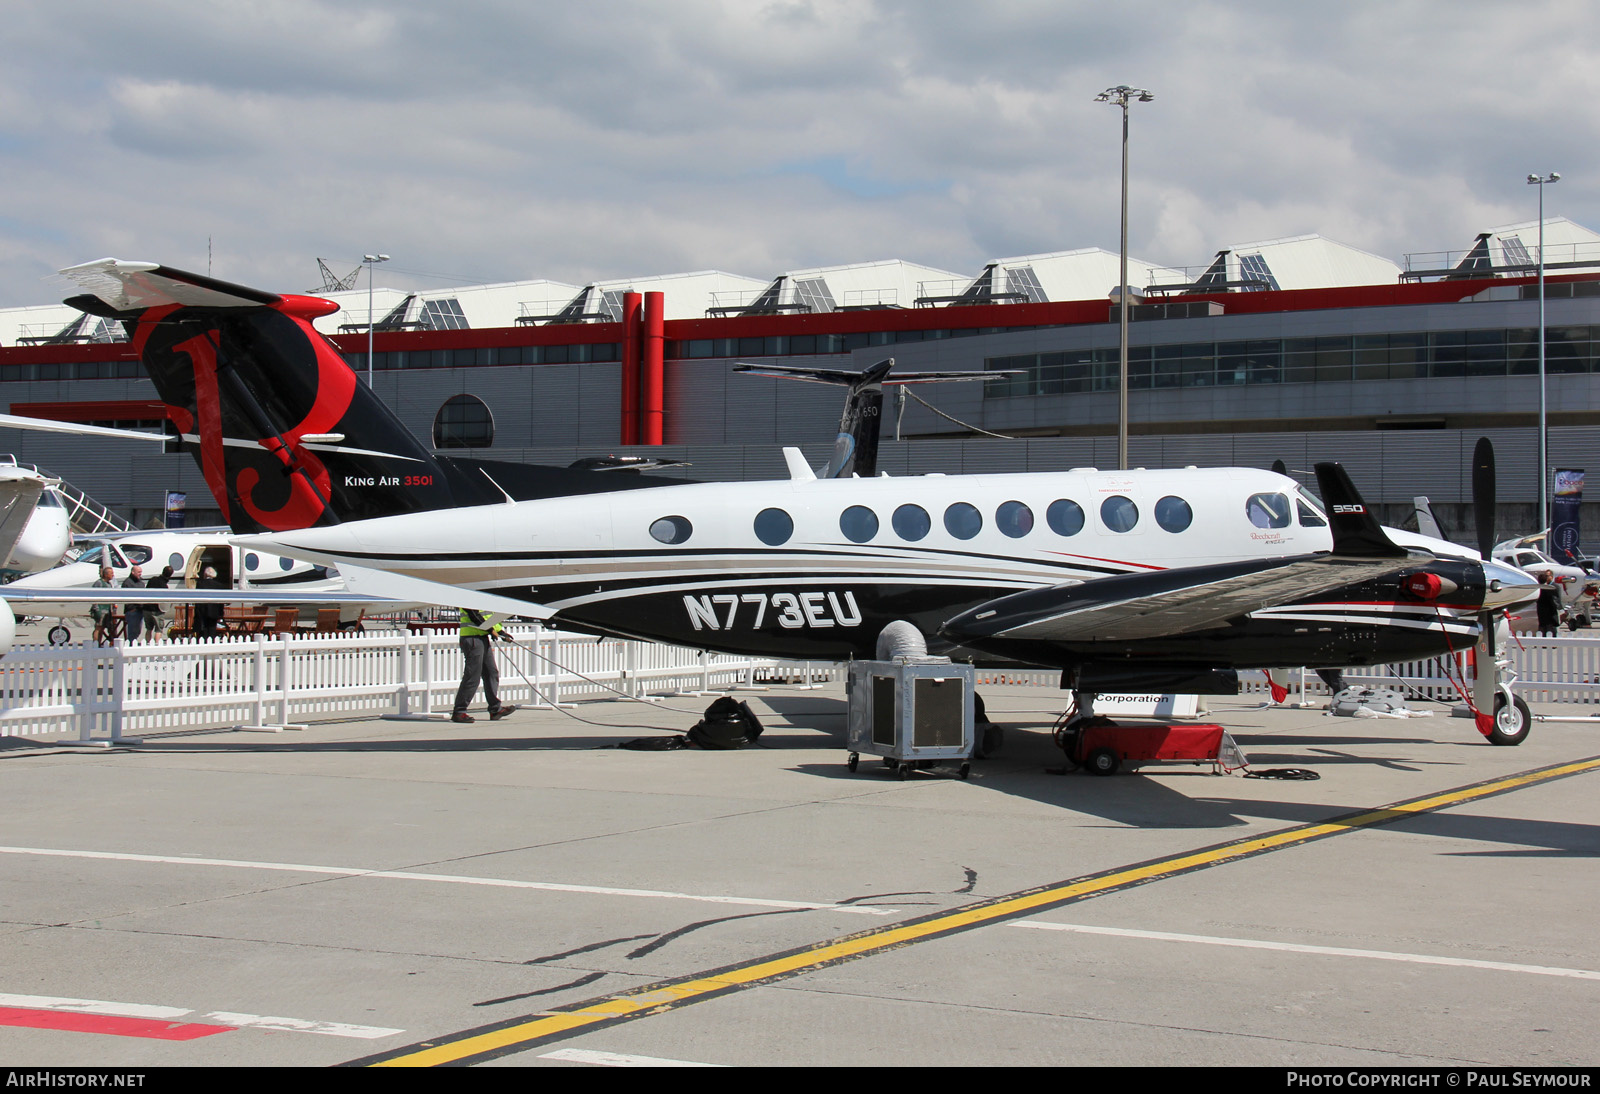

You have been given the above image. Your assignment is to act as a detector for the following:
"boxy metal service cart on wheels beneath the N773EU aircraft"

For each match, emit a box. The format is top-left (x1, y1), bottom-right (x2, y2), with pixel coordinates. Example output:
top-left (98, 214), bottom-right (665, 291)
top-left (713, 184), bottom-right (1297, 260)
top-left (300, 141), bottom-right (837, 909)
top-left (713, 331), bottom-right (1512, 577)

top-left (846, 657), bottom-right (978, 779)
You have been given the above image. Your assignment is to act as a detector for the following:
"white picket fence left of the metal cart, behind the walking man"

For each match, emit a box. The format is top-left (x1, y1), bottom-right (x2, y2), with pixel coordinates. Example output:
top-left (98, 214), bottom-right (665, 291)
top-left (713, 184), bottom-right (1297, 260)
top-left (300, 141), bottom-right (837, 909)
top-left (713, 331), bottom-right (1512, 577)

top-left (0, 627), bottom-right (778, 744)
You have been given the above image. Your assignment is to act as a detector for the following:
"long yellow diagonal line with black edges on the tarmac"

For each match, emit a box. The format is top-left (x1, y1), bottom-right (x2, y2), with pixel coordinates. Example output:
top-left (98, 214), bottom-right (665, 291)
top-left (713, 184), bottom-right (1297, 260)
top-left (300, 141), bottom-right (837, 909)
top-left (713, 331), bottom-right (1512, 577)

top-left (352, 757), bottom-right (1600, 1067)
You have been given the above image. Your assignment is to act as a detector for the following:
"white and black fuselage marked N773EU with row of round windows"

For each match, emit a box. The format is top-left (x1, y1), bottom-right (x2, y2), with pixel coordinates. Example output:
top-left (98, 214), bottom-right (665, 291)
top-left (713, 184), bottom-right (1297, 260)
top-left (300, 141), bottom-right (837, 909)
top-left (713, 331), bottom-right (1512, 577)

top-left (240, 469), bottom-right (1482, 667)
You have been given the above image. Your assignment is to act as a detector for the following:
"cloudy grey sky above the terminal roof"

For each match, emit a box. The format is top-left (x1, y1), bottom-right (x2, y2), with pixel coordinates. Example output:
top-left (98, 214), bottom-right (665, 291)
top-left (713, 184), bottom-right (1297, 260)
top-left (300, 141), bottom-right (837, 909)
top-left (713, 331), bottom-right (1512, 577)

top-left (0, 0), bottom-right (1600, 307)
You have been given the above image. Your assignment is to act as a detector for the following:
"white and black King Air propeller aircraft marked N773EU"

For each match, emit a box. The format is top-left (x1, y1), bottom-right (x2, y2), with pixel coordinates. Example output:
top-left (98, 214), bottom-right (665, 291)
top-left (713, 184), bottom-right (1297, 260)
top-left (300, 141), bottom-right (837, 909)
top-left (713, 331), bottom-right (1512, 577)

top-left (21, 259), bottom-right (1536, 744)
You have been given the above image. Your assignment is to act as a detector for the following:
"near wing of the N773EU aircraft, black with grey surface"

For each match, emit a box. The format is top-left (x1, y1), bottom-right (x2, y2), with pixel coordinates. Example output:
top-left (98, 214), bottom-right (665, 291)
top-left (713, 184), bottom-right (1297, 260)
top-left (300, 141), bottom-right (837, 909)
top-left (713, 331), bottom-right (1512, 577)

top-left (944, 553), bottom-right (1426, 641)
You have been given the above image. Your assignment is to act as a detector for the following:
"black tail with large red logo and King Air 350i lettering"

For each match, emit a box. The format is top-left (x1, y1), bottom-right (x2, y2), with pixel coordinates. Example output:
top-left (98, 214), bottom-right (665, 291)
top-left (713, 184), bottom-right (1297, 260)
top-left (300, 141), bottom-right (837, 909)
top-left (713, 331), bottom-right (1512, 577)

top-left (62, 259), bottom-right (486, 533)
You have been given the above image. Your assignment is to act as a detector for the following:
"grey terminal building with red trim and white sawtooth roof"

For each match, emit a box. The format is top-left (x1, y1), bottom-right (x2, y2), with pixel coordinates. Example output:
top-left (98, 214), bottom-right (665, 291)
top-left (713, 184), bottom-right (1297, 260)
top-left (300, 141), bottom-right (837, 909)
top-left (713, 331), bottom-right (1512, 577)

top-left (0, 218), bottom-right (1600, 537)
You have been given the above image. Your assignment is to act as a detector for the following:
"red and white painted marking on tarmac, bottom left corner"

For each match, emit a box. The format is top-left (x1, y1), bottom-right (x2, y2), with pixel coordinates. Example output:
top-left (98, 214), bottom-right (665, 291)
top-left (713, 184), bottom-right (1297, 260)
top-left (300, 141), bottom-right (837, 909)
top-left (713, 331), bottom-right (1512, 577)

top-left (0, 992), bottom-right (405, 1041)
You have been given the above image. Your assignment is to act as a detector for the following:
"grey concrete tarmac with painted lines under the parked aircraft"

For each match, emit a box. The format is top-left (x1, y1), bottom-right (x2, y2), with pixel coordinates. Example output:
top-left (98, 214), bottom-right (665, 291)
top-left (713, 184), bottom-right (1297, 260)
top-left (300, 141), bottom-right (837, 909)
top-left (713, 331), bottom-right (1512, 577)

top-left (0, 686), bottom-right (1600, 1070)
